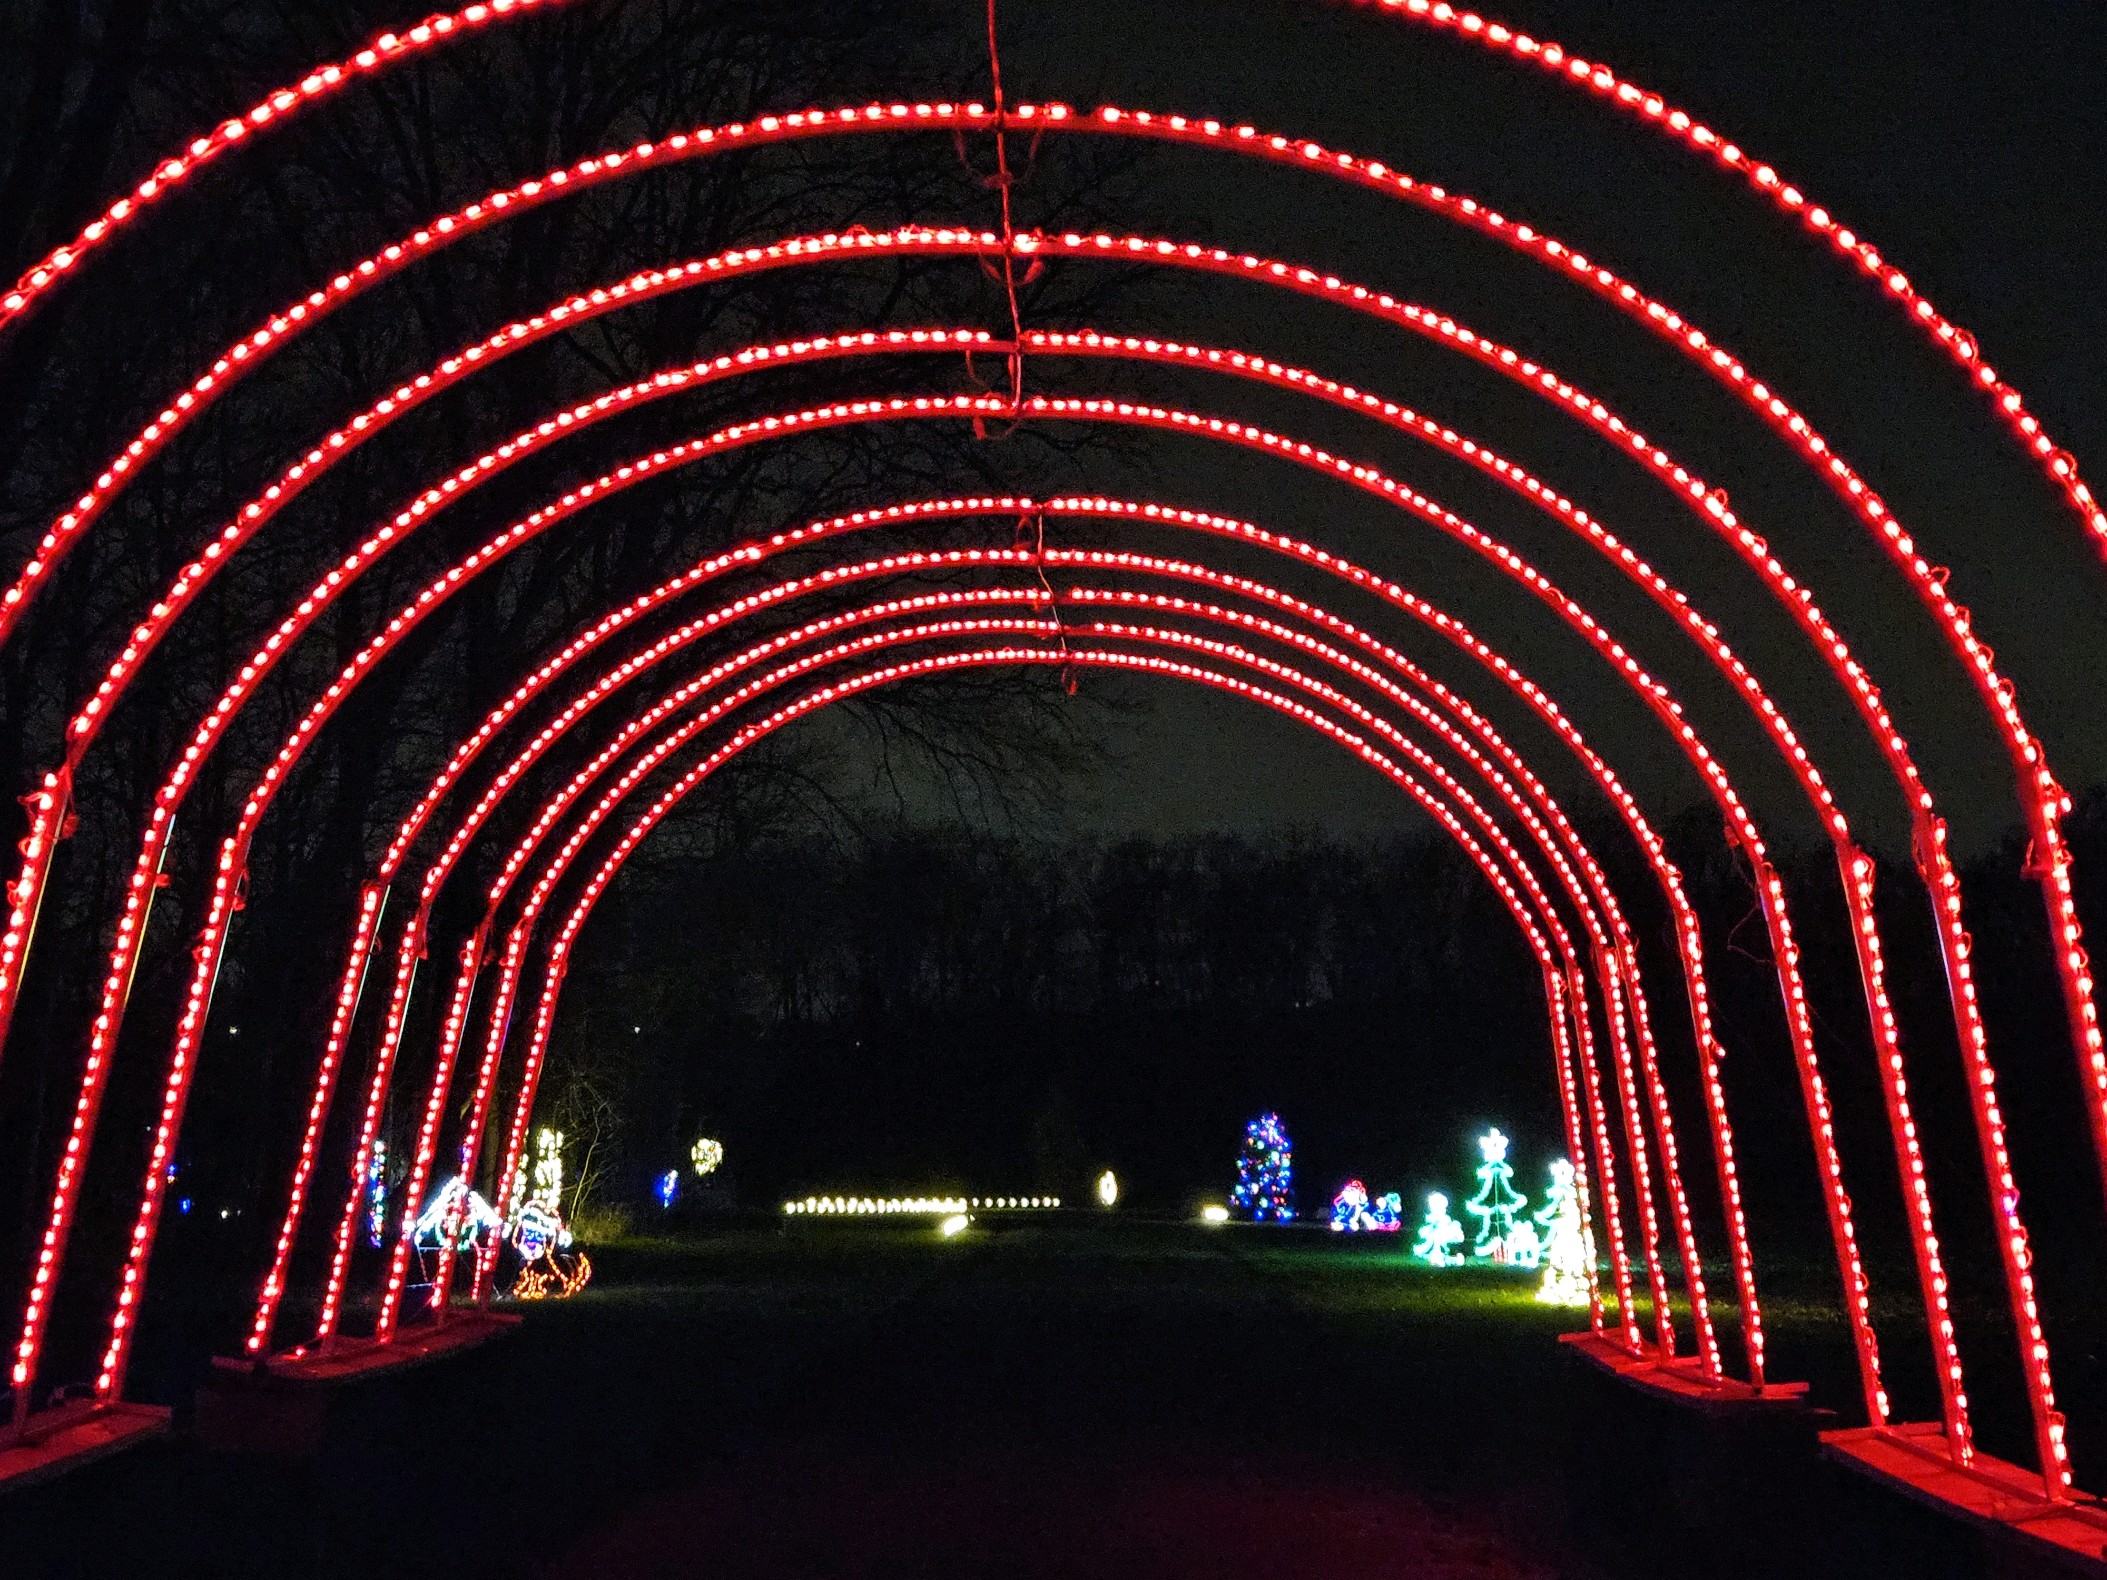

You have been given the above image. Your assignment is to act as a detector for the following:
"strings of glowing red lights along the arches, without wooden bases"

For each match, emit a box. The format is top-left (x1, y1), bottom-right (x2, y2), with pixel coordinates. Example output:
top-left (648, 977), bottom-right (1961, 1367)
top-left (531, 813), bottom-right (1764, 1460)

top-left (0, 0), bottom-right (2107, 1550)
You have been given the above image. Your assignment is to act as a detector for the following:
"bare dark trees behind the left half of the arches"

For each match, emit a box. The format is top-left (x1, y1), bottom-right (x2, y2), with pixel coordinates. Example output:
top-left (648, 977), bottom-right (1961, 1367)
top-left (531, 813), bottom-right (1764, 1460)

top-left (0, 0), bottom-right (1171, 1398)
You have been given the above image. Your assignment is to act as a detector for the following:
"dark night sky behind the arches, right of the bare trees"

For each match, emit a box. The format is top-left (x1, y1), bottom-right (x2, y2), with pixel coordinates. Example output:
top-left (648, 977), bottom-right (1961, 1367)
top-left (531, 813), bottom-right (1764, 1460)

top-left (859, 0), bottom-right (2107, 853)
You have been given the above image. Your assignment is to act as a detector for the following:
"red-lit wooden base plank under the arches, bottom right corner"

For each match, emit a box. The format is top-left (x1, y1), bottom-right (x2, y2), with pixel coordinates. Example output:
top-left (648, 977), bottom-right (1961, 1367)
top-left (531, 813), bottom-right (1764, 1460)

top-left (1823, 1422), bottom-right (2107, 1576)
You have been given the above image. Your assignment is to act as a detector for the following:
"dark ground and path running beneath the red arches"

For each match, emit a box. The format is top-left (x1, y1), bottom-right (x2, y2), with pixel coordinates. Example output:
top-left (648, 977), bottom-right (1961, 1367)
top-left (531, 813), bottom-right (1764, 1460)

top-left (0, 1218), bottom-right (2048, 1580)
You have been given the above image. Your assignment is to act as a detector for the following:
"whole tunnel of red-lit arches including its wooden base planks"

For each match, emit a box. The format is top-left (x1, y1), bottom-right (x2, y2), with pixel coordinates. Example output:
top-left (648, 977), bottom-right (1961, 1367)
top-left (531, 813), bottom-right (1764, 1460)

top-left (0, 0), bottom-right (2107, 1553)
